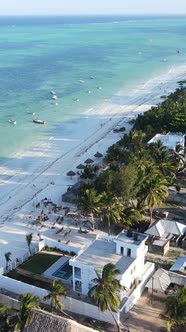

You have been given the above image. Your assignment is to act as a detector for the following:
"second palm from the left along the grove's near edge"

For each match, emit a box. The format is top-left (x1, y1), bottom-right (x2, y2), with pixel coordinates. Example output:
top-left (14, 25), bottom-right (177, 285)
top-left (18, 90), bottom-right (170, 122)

top-left (100, 193), bottom-right (123, 235)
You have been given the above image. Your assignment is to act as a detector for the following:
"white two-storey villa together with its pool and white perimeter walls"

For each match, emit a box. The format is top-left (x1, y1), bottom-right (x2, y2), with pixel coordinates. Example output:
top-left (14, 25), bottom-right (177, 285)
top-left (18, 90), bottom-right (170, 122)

top-left (0, 230), bottom-right (154, 324)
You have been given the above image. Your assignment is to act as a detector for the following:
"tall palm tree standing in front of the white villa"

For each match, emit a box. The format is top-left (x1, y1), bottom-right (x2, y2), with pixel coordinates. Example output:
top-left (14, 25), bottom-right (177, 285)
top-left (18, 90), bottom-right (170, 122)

top-left (88, 263), bottom-right (124, 332)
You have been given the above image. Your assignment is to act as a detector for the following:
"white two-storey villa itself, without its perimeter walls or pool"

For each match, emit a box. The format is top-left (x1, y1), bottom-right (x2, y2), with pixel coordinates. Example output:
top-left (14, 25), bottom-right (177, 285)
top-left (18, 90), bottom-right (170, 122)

top-left (69, 231), bottom-right (152, 300)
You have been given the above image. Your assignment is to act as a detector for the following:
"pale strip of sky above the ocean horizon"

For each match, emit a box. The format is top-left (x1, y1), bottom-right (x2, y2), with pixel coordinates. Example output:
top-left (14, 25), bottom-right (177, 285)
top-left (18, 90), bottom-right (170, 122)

top-left (0, 0), bottom-right (186, 15)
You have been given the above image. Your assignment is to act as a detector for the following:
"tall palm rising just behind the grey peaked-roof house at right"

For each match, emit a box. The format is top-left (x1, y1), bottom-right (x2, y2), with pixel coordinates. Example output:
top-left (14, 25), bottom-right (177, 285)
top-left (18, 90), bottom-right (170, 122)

top-left (145, 173), bottom-right (168, 223)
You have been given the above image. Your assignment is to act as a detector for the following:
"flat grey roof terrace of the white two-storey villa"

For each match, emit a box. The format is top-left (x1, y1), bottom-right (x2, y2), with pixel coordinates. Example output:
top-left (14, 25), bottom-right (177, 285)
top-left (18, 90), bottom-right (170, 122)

top-left (71, 239), bottom-right (135, 274)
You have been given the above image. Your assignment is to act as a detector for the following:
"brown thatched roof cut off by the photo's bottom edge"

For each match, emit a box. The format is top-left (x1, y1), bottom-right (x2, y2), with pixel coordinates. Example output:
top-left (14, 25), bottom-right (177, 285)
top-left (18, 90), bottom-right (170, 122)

top-left (23, 310), bottom-right (95, 332)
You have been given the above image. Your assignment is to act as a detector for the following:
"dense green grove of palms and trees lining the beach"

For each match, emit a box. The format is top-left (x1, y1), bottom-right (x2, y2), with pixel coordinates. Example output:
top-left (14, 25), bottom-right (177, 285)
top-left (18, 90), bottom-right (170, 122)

top-left (76, 88), bottom-right (186, 233)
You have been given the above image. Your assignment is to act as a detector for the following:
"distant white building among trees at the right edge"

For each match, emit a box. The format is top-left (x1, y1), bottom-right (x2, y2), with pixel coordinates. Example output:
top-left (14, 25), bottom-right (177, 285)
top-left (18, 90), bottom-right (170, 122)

top-left (147, 133), bottom-right (185, 153)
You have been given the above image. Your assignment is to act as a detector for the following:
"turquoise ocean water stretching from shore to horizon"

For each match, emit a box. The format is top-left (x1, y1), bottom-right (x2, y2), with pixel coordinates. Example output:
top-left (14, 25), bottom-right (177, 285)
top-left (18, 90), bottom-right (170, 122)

top-left (0, 16), bottom-right (186, 165)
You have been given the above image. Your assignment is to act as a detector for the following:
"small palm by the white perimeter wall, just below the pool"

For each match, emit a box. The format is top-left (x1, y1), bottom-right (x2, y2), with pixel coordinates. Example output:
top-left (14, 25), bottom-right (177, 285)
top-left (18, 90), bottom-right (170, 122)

top-left (43, 280), bottom-right (66, 311)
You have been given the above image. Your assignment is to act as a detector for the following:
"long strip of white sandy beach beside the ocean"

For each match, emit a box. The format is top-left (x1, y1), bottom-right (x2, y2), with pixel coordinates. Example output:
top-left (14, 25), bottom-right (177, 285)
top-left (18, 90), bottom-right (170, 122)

top-left (0, 66), bottom-right (186, 266)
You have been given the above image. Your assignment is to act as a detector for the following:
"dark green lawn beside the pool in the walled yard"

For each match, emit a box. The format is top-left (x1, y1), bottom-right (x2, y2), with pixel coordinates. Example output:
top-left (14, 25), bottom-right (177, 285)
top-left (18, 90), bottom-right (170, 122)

top-left (19, 254), bottom-right (60, 274)
